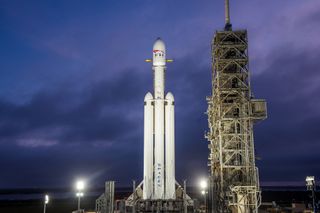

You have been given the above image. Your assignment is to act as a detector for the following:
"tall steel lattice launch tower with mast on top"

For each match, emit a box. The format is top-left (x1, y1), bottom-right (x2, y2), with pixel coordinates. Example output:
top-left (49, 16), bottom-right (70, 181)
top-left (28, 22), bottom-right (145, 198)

top-left (206, 0), bottom-right (267, 213)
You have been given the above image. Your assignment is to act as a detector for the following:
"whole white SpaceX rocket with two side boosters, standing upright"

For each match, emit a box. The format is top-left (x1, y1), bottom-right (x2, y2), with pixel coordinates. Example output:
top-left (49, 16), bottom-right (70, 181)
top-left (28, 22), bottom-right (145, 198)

top-left (143, 38), bottom-right (176, 199)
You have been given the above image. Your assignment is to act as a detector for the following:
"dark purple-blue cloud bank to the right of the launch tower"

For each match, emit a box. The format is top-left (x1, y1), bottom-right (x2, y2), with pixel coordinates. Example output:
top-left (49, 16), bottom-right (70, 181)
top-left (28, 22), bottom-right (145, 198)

top-left (252, 42), bottom-right (320, 181)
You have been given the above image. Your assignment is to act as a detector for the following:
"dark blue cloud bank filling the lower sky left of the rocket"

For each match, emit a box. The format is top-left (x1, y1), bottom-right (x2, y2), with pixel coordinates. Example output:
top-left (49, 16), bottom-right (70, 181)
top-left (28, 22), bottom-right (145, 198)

top-left (0, 70), bottom-right (146, 186)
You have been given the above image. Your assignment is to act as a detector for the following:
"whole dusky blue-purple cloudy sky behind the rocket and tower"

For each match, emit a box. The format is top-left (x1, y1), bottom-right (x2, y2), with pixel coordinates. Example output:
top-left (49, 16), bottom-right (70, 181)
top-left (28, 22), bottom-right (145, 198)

top-left (0, 0), bottom-right (320, 188)
